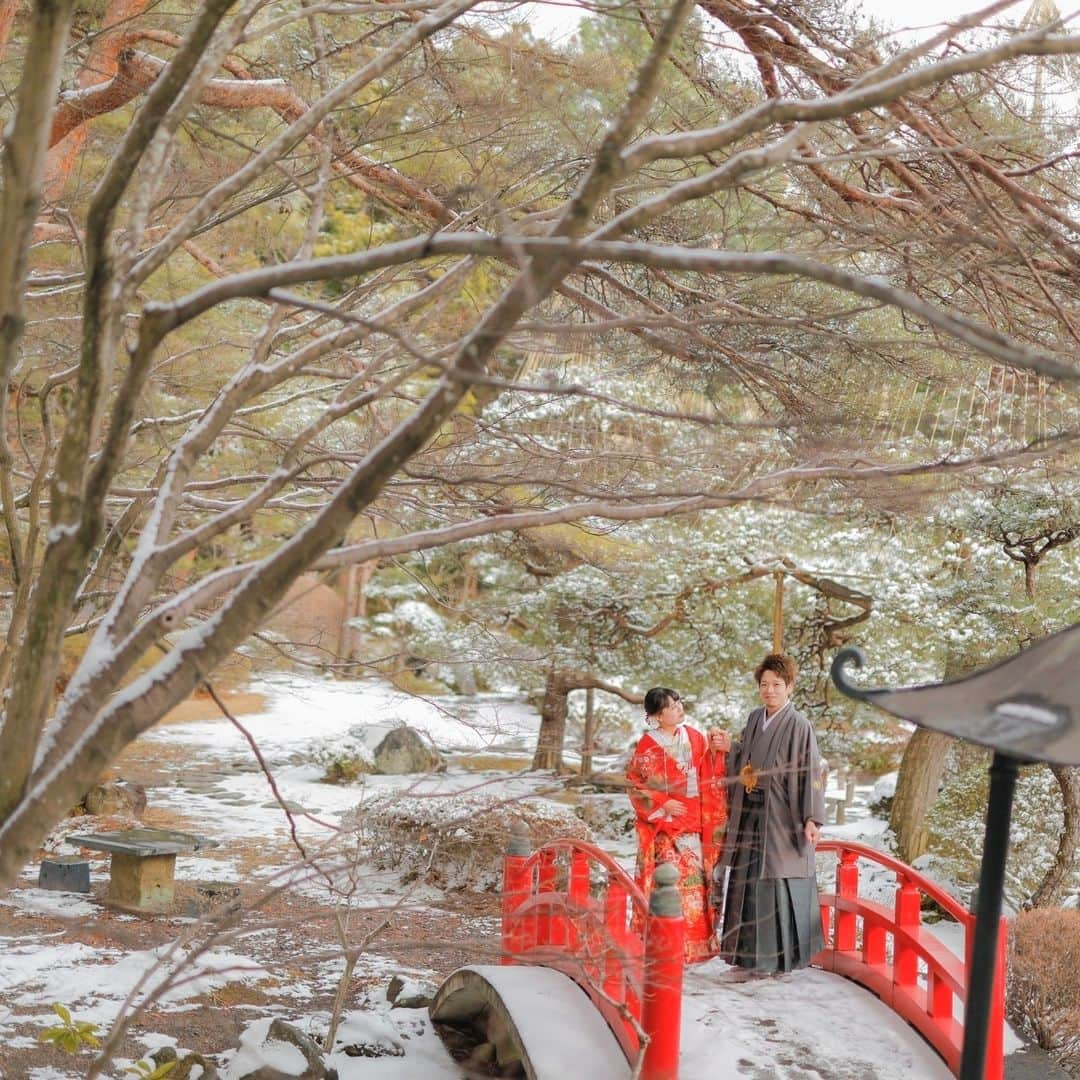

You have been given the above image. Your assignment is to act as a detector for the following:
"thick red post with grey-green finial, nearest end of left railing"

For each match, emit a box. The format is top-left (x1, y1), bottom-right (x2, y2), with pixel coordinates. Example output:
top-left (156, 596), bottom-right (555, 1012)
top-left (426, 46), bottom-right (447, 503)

top-left (642, 863), bottom-right (686, 1080)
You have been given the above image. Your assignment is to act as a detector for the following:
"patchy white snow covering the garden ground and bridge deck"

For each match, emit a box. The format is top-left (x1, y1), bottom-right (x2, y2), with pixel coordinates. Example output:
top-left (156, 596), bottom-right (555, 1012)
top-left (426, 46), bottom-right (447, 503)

top-left (0, 678), bottom-right (1010, 1080)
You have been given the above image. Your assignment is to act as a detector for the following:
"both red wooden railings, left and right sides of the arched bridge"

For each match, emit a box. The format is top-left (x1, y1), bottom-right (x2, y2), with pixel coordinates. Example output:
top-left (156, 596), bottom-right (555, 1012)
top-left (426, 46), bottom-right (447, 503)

top-left (502, 838), bottom-right (1005, 1080)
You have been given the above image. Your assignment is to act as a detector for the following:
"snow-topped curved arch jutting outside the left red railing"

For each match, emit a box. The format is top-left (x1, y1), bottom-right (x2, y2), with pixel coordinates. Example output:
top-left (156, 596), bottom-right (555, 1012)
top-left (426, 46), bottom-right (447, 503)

top-left (429, 964), bottom-right (631, 1080)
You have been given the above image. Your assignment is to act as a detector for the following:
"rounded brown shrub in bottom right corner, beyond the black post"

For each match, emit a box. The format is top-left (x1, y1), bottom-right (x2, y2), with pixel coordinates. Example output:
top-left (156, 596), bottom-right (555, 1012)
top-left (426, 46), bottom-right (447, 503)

top-left (1007, 907), bottom-right (1080, 1076)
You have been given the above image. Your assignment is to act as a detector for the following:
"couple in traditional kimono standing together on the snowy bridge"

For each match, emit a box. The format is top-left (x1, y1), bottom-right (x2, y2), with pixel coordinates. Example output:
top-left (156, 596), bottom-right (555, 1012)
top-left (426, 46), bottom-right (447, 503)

top-left (626, 652), bottom-right (825, 973)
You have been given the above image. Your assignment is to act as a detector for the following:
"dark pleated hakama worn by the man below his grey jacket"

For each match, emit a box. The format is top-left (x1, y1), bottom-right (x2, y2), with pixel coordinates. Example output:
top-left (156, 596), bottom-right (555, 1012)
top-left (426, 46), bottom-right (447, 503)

top-left (720, 793), bottom-right (825, 972)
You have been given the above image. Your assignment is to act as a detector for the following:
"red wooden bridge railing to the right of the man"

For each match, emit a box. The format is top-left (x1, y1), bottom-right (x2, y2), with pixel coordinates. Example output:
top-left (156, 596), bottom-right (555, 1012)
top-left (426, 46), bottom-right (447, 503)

top-left (813, 840), bottom-right (1005, 1080)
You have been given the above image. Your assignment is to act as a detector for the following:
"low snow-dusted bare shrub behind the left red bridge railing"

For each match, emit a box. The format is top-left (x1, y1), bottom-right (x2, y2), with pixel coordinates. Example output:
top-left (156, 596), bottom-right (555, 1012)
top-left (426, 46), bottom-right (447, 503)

top-left (345, 794), bottom-right (593, 891)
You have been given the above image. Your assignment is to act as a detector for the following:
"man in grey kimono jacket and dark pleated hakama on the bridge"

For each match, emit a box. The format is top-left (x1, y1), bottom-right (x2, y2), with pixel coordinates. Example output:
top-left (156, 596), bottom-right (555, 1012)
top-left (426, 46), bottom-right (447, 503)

top-left (713, 653), bottom-right (825, 972)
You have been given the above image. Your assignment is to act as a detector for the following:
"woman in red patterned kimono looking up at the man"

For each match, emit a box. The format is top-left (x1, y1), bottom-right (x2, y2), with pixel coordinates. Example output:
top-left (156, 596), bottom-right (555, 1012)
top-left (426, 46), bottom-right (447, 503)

top-left (626, 686), bottom-right (731, 962)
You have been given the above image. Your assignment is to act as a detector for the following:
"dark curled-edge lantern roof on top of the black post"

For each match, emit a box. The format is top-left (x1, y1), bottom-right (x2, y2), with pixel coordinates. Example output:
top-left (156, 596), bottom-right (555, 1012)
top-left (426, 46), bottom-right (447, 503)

top-left (833, 623), bottom-right (1080, 765)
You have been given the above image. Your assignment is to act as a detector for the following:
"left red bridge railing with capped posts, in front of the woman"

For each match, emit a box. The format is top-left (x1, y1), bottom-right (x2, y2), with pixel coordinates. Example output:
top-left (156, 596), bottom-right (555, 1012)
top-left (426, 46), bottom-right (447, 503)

top-left (502, 837), bottom-right (685, 1080)
